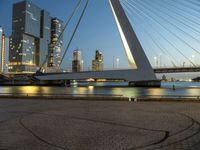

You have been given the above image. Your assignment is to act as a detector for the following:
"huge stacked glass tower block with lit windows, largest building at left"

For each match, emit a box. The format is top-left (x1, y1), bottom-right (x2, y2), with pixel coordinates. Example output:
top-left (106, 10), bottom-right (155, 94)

top-left (9, 1), bottom-right (51, 72)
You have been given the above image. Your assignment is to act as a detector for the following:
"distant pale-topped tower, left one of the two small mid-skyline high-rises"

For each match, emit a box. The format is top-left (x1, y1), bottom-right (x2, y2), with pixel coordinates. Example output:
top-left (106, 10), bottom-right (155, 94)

top-left (72, 49), bottom-right (83, 72)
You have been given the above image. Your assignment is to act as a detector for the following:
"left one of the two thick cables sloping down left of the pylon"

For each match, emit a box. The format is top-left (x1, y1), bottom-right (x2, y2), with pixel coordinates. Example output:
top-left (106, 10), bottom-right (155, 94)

top-left (38, 0), bottom-right (82, 72)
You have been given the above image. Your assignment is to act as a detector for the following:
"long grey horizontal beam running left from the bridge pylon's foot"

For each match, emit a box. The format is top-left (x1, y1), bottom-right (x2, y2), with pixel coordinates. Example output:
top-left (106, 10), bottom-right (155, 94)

top-left (35, 69), bottom-right (157, 81)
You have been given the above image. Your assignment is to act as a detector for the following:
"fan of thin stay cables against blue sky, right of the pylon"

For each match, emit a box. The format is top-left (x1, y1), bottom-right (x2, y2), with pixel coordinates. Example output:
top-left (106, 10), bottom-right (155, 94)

top-left (120, 0), bottom-right (200, 67)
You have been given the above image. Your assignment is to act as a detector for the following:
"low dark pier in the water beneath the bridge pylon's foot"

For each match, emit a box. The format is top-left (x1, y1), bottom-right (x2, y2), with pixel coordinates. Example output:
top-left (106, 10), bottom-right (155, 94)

top-left (129, 80), bottom-right (161, 87)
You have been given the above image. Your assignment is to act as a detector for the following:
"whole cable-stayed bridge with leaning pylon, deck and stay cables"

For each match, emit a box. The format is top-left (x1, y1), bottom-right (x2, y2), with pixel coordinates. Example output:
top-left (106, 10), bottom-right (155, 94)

top-left (35, 0), bottom-right (200, 86)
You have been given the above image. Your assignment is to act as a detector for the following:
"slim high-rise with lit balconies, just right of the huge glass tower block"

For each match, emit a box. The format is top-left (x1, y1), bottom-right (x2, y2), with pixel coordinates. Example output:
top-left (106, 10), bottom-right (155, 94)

top-left (48, 18), bottom-right (63, 67)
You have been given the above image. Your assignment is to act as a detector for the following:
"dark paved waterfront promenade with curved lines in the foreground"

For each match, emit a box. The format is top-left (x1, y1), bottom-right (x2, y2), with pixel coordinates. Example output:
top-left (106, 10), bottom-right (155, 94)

top-left (0, 99), bottom-right (200, 150)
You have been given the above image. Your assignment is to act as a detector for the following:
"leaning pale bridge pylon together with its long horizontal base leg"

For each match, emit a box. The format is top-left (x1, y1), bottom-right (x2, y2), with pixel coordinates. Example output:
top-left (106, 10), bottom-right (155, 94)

top-left (36, 0), bottom-right (157, 86)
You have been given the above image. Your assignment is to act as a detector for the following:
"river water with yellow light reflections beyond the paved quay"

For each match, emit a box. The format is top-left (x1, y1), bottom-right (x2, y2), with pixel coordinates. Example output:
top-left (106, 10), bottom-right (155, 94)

top-left (0, 82), bottom-right (200, 98)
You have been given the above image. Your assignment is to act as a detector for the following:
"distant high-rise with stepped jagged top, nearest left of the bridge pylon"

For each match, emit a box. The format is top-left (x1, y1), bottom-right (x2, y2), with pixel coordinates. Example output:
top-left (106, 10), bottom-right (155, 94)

top-left (92, 50), bottom-right (103, 71)
